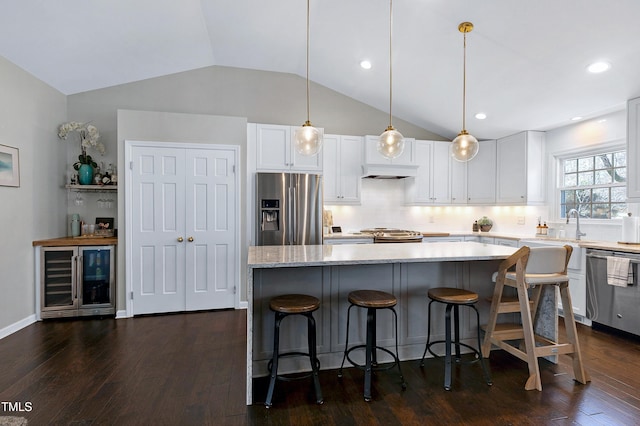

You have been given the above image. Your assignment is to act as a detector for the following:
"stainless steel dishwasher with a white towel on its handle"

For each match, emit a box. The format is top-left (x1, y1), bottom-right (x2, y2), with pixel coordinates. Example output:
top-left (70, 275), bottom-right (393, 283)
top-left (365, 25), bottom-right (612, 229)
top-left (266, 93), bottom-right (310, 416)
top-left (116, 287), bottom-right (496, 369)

top-left (586, 249), bottom-right (640, 335)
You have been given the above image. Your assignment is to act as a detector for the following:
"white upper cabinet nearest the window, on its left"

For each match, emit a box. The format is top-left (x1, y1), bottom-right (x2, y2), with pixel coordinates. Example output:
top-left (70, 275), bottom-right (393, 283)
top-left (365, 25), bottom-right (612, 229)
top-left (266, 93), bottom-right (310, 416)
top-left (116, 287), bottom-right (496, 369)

top-left (496, 131), bottom-right (545, 204)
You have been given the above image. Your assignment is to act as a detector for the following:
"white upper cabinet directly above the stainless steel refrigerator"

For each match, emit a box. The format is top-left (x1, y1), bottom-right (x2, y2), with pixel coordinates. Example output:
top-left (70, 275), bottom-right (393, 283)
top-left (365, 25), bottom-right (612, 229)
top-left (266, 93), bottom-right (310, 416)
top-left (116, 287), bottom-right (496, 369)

top-left (247, 123), bottom-right (322, 173)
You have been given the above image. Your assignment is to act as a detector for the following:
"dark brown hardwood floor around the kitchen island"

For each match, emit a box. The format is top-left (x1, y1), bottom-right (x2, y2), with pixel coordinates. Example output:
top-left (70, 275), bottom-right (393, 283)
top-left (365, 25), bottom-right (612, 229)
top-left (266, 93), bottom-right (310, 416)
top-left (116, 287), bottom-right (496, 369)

top-left (0, 310), bottom-right (640, 425)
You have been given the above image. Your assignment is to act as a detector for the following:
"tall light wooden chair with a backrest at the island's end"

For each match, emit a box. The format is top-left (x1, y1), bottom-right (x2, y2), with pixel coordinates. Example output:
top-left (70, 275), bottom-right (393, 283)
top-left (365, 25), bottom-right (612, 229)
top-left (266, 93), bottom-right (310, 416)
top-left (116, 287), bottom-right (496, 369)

top-left (482, 245), bottom-right (590, 391)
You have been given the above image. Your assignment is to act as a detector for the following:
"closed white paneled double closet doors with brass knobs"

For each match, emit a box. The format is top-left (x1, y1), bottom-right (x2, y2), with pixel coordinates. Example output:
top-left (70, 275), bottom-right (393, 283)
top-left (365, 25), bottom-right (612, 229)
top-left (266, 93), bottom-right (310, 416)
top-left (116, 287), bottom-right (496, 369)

top-left (128, 143), bottom-right (238, 315)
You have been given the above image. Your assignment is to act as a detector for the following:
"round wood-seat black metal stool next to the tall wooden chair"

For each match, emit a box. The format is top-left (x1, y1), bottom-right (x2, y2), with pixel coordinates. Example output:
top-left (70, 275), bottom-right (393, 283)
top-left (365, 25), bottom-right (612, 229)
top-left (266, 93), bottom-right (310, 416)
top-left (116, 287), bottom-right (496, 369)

top-left (420, 287), bottom-right (492, 390)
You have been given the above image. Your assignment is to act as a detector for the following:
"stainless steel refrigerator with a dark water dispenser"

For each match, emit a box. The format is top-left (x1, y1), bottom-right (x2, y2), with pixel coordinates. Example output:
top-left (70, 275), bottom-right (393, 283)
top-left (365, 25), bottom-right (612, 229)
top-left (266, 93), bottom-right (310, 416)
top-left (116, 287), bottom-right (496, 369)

top-left (256, 173), bottom-right (322, 246)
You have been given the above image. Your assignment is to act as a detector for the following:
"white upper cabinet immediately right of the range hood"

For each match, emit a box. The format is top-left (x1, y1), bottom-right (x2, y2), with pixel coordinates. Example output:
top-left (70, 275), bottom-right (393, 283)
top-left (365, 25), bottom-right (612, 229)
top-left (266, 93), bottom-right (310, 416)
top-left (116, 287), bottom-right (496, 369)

top-left (405, 140), bottom-right (451, 205)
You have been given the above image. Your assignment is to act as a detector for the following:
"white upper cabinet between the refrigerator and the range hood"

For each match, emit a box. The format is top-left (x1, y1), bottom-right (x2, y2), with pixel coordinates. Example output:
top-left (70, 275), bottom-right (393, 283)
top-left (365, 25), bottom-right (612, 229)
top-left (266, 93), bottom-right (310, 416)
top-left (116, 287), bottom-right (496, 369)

top-left (322, 135), bottom-right (364, 204)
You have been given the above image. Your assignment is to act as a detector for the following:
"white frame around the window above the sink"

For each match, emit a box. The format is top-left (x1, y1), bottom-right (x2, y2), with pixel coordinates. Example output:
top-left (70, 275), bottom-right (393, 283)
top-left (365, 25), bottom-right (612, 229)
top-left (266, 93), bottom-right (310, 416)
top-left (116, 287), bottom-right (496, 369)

top-left (550, 139), bottom-right (629, 224)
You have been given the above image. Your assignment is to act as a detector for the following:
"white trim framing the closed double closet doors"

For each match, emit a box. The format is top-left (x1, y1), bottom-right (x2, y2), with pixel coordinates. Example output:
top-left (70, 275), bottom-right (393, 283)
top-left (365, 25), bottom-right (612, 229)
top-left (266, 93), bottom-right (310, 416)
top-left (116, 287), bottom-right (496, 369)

top-left (125, 140), bottom-right (242, 317)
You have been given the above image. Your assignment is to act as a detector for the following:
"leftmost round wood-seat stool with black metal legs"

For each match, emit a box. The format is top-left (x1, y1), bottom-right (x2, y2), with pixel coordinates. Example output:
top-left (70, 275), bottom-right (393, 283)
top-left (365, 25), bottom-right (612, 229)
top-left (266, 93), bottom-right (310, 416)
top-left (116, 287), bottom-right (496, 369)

top-left (264, 294), bottom-right (324, 408)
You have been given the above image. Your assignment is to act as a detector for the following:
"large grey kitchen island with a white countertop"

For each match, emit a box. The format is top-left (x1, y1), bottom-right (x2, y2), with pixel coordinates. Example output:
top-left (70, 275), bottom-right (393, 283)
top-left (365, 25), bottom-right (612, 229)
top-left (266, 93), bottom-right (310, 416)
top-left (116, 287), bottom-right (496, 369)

top-left (247, 242), bottom-right (557, 404)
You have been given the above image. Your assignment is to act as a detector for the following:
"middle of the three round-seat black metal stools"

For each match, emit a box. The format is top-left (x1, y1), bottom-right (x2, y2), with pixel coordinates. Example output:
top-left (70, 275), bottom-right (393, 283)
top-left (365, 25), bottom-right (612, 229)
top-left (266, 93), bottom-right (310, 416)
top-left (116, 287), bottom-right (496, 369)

top-left (338, 290), bottom-right (407, 402)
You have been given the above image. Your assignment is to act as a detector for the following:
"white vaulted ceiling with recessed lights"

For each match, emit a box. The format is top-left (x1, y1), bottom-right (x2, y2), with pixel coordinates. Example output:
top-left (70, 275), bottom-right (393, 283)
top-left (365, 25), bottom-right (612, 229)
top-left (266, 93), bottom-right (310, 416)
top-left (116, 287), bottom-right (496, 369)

top-left (0, 0), bottom-right (640, 139)
